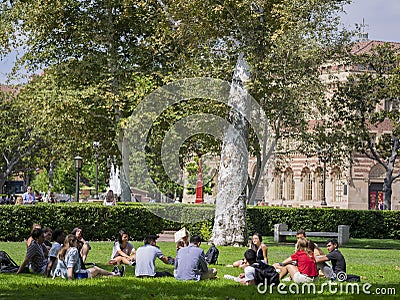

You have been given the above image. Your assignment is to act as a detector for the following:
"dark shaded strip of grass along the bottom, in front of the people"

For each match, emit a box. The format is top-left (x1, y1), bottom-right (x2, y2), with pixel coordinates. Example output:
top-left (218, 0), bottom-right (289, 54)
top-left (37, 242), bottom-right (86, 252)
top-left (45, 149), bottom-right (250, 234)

top-left (0, 275), bottom-right (399, 300)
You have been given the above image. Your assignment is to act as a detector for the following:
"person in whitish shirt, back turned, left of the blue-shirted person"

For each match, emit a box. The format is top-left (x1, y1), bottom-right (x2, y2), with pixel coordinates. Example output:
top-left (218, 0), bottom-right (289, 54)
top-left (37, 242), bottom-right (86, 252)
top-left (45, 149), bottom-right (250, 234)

top-left (135, 235), bottom-right (174, 278)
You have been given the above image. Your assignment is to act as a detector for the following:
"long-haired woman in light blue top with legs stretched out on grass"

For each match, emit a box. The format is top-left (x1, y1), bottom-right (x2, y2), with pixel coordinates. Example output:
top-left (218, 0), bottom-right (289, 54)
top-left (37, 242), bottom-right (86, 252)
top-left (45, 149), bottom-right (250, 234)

top-left (53, 234), bottom-right (125, 280)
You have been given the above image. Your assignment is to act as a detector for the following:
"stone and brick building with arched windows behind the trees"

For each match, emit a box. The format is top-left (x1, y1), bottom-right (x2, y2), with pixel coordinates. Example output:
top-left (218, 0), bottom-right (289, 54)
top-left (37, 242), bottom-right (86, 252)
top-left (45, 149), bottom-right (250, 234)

top-left (260, 41), bottom-right (400, 210)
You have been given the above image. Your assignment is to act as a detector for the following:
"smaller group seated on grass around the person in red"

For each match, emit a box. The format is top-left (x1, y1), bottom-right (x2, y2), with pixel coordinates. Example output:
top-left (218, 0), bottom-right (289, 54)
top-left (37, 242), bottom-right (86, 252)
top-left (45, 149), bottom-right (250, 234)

top-left (225, 230), bottom-right (346, 285)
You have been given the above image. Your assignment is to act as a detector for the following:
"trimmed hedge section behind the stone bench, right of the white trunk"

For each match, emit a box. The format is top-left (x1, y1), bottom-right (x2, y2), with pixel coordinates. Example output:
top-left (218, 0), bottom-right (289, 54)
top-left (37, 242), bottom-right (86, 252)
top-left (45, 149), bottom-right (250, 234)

top-left (247, 207), bottom-right (400, 239)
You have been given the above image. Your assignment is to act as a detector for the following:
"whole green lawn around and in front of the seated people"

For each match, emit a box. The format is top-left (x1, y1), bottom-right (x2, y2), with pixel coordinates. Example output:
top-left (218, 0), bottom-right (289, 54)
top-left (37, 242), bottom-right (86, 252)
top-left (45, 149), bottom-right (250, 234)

top-left (0, 237), bottom-right (400, 300)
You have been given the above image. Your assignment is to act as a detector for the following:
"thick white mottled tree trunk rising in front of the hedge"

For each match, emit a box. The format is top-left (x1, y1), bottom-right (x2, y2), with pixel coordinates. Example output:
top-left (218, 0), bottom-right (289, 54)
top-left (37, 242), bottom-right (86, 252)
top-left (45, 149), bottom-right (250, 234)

top-left (210, 54), bottom-right (249, 245)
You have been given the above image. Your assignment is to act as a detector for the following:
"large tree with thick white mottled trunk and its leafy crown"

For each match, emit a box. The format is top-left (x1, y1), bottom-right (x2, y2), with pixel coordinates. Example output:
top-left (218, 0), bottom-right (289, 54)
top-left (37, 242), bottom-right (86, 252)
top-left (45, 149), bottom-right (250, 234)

top-left (152, 0), bottom-right (349, 245)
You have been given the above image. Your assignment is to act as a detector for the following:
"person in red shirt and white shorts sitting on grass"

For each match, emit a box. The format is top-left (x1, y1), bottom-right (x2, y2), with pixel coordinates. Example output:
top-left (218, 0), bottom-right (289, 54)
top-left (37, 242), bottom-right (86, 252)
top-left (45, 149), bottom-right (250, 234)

top-left (279, 238), bottom-right (318, 283)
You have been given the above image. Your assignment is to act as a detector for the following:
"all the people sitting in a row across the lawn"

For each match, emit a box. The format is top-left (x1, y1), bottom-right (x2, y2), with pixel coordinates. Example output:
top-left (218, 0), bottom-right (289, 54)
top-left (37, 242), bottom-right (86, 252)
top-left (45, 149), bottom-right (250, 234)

top-left (17, 224), bottom-right (346, 285)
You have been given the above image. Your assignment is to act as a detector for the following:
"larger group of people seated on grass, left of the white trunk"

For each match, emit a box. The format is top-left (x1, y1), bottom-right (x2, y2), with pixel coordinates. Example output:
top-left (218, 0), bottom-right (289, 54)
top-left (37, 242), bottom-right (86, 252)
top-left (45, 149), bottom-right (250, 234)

top-left (17, 224), bottom-right (217, 280)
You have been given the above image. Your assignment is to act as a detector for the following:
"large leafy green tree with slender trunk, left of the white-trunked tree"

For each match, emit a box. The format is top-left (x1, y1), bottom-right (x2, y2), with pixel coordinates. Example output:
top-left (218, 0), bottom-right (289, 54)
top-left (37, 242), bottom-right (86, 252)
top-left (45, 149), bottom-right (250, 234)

top-left (1, 0), bottom-right (171, 200)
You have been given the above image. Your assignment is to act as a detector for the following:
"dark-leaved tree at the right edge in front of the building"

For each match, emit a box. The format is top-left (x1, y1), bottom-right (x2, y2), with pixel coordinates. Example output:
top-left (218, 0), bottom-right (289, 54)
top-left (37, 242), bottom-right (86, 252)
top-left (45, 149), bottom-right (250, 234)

top-left (329, 44), bottom-right (400, 209)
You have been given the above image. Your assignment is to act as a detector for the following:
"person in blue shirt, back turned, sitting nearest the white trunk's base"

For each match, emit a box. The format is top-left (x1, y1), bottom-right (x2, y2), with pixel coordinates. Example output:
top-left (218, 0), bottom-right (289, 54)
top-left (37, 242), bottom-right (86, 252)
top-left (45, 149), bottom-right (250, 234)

top-left (174, 235), bottom-right (217, 281)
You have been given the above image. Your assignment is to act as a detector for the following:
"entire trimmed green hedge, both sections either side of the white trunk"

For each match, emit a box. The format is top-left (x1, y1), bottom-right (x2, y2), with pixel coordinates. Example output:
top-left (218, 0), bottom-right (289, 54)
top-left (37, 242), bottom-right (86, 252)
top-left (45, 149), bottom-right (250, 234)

top-left (0, 203), bottom-right (400, 241)
